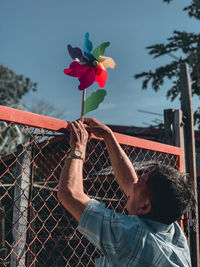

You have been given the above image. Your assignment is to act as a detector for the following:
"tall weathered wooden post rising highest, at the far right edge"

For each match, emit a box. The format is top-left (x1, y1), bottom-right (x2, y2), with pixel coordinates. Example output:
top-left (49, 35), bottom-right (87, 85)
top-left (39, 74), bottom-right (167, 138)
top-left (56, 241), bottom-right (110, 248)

top-left (180, 63), bottom-right (200, 267)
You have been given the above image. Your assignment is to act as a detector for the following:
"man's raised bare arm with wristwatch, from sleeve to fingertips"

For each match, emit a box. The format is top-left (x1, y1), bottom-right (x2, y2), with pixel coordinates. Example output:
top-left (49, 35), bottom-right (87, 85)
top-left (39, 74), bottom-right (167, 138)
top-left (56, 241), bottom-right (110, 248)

top-left (58, 121), bottom-right (90, 221)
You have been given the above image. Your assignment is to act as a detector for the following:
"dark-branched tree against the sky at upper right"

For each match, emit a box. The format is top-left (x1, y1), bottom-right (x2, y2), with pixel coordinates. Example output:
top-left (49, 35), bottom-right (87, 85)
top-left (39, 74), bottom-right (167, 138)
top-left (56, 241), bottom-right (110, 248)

top-left (134, 0), bottom-right (200, 129)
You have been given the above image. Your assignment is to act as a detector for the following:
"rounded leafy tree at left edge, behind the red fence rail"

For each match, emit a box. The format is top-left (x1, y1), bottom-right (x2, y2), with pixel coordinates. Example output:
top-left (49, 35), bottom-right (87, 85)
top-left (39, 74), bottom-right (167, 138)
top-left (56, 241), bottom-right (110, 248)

top-left (0, 65), bottom-right (37, 156)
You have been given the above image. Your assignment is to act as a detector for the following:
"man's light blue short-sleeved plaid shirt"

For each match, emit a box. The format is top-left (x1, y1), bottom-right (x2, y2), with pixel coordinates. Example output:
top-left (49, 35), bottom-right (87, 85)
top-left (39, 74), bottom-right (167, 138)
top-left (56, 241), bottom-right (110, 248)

top-left (78, 199), bottom-right (191, 267)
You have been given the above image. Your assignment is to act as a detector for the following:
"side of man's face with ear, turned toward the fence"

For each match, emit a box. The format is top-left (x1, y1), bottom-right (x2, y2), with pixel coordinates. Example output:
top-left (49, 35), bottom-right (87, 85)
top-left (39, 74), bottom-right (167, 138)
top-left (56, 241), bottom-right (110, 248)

top-left (126, 173), bottom-right (150, 215)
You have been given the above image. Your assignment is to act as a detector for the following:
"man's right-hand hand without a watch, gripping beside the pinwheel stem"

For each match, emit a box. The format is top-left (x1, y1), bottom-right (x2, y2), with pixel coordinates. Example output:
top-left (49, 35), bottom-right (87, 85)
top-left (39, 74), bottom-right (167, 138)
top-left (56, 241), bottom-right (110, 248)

top-left (83, 118), bottom-right (112, 138)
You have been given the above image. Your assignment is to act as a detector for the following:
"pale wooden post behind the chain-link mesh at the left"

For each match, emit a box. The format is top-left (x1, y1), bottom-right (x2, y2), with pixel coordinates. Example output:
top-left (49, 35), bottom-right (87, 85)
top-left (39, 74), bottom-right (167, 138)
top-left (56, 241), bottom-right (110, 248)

top-left (10, 145), bottom-right (31, 267)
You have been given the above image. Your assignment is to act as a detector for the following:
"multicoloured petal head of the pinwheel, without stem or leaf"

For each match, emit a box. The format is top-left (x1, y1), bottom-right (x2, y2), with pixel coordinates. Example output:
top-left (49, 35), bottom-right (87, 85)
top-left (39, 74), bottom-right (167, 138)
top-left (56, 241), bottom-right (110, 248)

top-left (64, 33), bottom-right (116, 90)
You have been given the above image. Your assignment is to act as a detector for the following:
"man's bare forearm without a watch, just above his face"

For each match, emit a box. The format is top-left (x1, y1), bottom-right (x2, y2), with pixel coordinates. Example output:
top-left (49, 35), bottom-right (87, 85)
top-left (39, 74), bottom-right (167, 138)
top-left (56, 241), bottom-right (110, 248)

top-left (104, 132), bottom-right (138, 196)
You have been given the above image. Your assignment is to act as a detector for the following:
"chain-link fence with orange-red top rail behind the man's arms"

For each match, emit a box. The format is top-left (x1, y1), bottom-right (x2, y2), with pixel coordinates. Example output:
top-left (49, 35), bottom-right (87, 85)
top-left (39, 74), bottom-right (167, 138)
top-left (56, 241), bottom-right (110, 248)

top-left (0, 108), bottom-right (182, 267)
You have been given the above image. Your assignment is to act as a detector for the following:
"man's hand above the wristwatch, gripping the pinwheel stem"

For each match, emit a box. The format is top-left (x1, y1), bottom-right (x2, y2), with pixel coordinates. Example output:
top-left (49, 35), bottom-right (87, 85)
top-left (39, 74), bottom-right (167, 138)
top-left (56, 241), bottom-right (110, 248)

top-left (68, 121), bottom-right (88, 153)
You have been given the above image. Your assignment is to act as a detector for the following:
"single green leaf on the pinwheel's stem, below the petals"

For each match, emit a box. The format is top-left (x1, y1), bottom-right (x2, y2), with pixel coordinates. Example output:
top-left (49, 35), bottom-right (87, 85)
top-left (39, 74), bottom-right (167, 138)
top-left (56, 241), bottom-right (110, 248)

top-left (83, 89), bottom-right (107, 115)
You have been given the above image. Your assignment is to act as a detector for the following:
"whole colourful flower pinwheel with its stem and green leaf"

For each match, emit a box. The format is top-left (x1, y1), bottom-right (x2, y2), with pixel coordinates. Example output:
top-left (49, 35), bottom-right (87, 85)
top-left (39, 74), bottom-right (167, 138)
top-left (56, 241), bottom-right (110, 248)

top-left (64, 33), bottom-right (116, 120)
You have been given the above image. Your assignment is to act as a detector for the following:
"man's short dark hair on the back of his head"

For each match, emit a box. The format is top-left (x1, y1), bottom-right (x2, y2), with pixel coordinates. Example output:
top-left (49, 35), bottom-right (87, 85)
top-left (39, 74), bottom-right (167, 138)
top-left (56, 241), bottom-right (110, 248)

top-left (147, 162), bottom-right (194, 224)
